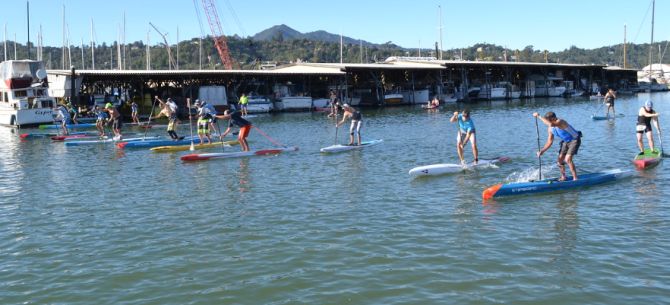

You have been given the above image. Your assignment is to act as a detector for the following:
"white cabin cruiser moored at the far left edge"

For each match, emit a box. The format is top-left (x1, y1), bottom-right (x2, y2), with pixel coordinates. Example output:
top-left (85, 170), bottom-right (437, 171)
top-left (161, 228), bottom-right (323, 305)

top-left (0, 60), bottom-right (56, 127)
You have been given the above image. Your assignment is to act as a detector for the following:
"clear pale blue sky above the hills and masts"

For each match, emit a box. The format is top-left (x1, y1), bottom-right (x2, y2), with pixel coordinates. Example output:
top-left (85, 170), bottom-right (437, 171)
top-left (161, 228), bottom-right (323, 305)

top-left (0, 0), bottom-right (670, 51)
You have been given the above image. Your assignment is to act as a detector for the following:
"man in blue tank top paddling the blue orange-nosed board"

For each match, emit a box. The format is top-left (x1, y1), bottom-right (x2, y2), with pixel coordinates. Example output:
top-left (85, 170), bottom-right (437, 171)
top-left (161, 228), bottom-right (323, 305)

top-left (533, 111), bottom-right (582, 181)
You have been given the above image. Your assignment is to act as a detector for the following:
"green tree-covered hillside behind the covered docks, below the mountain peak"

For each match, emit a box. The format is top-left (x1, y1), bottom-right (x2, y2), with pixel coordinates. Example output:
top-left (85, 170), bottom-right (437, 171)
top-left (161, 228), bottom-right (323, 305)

top-left (4, 35), bottom-right (668, 70)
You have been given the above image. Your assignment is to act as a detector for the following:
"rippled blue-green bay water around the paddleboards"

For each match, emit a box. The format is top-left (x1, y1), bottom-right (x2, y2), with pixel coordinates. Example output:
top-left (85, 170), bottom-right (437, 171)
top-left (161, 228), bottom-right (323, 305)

top-left (0, 93), bottom-right (670, 304)
